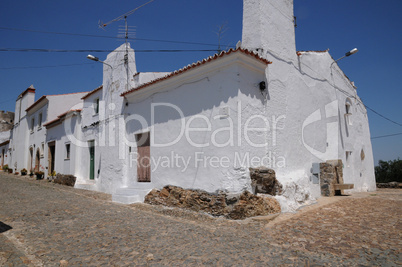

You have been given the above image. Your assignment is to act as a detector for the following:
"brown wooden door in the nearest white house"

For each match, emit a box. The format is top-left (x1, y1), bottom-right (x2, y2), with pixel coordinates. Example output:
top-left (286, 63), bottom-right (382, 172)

top-left (135, 132), bottom-right (151, 182)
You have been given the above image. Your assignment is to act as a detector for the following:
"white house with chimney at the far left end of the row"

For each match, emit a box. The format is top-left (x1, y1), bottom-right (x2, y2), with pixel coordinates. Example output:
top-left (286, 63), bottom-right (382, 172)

top-left (10, 86), bottom-right (86, 176)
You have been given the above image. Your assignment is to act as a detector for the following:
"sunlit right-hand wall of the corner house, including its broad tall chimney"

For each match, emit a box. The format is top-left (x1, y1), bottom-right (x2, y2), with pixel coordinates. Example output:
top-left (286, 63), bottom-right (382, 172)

top-left (242, 0), bottom-right (375, 210)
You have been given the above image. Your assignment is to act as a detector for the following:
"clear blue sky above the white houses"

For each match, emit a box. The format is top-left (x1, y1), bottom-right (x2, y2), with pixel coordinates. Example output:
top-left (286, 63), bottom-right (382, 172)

top-left (0, 0), bottom-right (402, 163)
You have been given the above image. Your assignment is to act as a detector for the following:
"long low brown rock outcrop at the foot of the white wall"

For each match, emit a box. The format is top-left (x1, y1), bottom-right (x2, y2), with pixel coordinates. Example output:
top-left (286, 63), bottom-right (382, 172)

top-left (145, 185), bottom-right (281, 220)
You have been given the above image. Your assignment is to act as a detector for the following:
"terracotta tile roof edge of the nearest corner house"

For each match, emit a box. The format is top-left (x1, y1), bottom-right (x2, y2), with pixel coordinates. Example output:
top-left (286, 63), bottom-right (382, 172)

top-left (120, 48), bottom-right (272, 96)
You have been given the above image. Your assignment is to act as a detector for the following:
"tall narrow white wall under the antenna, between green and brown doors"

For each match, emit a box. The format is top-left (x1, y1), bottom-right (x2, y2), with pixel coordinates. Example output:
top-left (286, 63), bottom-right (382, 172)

top-left (88, 44), bottom-right (137, 193)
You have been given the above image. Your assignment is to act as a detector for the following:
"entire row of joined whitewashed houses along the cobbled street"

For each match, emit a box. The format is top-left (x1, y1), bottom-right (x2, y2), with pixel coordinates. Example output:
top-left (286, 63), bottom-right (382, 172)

top-left (3, 0), bottom-right (375, 211)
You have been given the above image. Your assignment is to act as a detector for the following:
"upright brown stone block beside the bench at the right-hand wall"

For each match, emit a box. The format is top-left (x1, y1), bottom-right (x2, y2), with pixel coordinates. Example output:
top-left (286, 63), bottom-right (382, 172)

top-left (320, 159), bottom-right (343, 197)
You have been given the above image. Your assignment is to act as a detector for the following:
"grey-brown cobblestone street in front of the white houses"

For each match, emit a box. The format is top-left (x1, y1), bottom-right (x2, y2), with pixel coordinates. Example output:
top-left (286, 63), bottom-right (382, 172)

top-left (0, 173), bottom-right (402, 266)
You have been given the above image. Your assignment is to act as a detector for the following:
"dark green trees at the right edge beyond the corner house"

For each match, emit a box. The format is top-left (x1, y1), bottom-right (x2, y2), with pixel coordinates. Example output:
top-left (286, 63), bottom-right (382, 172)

top-left (375, 158), bottom-right (402, 183)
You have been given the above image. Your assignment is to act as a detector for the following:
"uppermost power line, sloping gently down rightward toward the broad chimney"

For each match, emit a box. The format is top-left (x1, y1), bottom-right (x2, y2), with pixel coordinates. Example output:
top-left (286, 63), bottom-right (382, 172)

top-left (0, 27), bottom-right (226, 47)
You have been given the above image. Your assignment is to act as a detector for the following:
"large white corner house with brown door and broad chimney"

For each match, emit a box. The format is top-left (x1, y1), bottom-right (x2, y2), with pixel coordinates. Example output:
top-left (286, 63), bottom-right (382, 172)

top-left (109, 0), bottom-right (375, 207)
